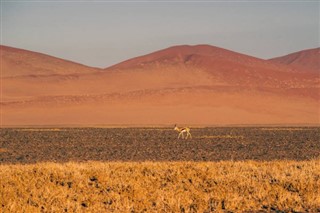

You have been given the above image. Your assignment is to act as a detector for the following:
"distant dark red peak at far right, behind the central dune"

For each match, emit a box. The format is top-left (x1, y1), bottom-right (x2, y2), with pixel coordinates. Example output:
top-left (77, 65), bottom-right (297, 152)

top-left (269, 47), bottom-right (320, 73)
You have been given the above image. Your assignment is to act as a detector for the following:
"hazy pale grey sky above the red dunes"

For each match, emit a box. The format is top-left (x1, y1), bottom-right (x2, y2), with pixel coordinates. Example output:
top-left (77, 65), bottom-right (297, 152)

top-left (0, 0), bottom-right (320, 67)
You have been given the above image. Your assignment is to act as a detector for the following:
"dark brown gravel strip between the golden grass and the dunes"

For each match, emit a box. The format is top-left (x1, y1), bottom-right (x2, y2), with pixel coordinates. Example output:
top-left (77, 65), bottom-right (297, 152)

top-left (0, 127), bottom-right (320, 164)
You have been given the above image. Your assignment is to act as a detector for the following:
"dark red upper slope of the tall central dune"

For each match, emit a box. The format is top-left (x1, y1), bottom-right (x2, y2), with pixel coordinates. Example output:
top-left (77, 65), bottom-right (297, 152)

top-left (105, 45), bottom-right (316, 87)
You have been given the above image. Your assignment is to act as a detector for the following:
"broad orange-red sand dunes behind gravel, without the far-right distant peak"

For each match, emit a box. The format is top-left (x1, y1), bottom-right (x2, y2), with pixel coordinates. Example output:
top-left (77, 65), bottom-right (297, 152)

top-left (1, 45), bottom-right (320, 126)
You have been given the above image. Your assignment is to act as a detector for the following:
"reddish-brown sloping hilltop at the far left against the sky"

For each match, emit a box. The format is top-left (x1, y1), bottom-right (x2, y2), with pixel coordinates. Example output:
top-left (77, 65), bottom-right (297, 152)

top-left (0, 45), bottom-right (97, 77)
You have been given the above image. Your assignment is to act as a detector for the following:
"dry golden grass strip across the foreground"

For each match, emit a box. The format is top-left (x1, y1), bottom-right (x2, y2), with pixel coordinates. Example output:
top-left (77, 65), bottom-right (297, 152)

top-left (0, 160), bottom-right (320, 212)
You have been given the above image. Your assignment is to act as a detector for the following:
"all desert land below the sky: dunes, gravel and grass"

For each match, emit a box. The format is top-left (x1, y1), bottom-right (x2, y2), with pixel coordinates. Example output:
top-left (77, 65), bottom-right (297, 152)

top-left (0, 45), bottom-right (320, 212)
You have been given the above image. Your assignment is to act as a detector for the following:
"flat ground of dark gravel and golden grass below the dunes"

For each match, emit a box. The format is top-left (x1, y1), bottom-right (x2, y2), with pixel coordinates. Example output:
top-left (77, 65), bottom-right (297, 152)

top-left (0, 127), bottom-right (320, 213)
